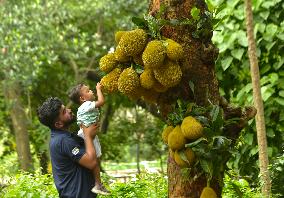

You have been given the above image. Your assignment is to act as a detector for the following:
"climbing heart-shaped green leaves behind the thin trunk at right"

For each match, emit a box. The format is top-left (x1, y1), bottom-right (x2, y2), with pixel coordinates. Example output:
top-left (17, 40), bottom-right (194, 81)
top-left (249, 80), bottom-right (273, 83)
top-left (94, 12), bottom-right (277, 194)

top-left (209, 0), bottom-right (284, 191)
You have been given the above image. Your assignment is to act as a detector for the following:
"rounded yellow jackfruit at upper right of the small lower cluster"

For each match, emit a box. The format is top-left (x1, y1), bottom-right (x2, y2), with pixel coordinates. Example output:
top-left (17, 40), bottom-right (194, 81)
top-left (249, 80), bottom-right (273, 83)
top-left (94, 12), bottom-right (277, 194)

top-left (181, 116), bottom-right (203, 140)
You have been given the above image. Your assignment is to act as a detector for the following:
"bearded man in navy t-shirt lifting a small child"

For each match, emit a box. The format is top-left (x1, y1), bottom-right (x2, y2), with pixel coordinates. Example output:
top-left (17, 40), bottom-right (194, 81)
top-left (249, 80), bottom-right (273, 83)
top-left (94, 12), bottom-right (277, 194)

top-left (37, 97), bottom-right (97, 198)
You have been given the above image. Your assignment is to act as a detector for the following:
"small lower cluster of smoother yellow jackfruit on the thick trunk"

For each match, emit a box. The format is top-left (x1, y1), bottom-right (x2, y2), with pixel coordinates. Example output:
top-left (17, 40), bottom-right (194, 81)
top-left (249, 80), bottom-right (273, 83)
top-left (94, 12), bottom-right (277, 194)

top-left (162, 116), bottom-right (203, 167)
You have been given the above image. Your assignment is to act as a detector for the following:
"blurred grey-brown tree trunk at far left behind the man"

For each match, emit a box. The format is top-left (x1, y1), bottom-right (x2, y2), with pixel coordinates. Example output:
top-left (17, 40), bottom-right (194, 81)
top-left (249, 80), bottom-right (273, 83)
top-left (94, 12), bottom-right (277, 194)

top-left (3, 81), bottom-right (33, 171)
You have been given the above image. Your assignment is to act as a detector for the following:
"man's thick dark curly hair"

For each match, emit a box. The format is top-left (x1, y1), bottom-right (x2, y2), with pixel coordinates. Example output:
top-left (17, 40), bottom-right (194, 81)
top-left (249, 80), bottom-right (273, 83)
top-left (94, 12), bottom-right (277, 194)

top-left (37, 97), bottom-right (63, 129)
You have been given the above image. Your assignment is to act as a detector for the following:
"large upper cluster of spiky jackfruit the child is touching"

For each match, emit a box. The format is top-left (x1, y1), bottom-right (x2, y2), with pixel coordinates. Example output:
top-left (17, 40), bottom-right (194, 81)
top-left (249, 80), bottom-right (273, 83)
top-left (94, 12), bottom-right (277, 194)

top-left (99, 29), bottom-right (184, 103)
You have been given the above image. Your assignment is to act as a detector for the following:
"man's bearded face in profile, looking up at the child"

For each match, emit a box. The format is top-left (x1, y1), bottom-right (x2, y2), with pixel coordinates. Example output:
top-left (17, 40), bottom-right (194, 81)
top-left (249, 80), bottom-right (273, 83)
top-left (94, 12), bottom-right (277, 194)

top-left (55, 105), bottom-right (76, 129)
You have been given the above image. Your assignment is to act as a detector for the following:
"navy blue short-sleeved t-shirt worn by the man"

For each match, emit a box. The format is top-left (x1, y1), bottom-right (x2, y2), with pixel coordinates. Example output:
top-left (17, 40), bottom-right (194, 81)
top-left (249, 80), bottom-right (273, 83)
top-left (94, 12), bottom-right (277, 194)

top-left (49, 131), bottom-right (96, 198)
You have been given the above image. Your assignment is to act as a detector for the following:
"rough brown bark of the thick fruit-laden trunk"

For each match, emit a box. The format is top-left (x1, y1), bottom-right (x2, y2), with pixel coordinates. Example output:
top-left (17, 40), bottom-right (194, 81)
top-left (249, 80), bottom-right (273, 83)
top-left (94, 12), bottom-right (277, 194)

top-left (149, 0), bottom-right (255, 198)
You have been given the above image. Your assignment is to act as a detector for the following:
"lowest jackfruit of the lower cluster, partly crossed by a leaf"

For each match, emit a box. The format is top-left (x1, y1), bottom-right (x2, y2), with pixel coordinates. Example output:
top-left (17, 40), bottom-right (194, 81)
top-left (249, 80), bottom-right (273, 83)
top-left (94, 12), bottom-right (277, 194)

top-left (174, 148), bottom-right (195, 167)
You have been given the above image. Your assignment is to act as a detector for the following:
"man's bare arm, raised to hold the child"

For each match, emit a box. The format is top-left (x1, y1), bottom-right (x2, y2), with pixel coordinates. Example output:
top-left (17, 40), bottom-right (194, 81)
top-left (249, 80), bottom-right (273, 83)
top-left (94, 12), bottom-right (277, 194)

top-left (79, 124), bottom-right (98, 170)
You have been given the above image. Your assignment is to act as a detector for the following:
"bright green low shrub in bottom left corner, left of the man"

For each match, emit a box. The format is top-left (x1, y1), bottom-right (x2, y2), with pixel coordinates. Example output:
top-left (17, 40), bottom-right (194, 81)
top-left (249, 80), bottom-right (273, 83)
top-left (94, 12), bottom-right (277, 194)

top-left (0, 173), bottom-right (58, 198)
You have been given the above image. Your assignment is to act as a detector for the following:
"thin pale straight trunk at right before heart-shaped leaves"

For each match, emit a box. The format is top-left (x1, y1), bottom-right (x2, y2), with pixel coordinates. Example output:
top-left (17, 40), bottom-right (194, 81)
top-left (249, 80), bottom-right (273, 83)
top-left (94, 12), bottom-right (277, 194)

top-left (245, 0), bottom-right (271, 197)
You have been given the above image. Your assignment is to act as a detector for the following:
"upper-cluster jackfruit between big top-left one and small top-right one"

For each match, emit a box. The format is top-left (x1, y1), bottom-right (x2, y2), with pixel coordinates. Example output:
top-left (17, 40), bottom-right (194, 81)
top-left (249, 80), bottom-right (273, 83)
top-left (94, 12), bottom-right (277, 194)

top-left (142, 40), bottom-right (166, 68)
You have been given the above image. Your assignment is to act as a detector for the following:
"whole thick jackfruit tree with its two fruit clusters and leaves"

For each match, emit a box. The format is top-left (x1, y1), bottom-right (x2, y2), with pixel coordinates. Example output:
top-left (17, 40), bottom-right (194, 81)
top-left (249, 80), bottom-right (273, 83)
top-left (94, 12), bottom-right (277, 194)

top-left (97, 0), bottom-right (256, 198)
